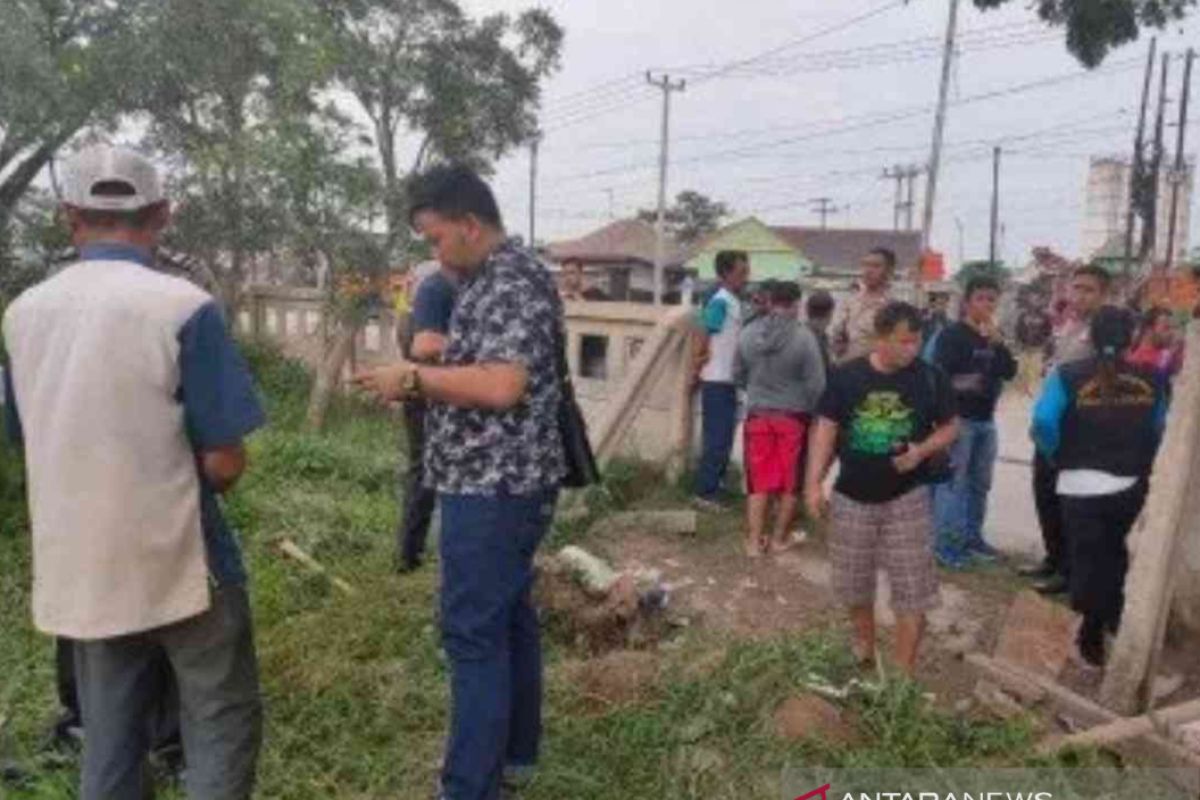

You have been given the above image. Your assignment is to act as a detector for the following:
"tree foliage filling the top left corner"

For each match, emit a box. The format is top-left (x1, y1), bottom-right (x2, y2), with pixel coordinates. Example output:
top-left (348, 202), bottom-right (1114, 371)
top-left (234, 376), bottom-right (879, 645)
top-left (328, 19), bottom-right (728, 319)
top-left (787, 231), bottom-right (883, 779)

top-left (0, 0), bottom-right (155, 235)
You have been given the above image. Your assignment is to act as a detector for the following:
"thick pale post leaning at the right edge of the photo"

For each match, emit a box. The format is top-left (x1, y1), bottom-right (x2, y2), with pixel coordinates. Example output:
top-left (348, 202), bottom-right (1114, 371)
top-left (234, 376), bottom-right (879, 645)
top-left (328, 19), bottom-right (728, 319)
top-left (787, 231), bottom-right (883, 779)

top-left (1100, 325), bottom-right (1200, 714)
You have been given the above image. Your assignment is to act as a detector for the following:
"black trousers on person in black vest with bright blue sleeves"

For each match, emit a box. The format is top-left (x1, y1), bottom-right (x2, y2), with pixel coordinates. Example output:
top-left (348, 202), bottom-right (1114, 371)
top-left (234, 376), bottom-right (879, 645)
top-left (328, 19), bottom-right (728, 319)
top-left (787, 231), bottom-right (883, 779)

top-left (1062, 481), bottom-right (1147, 642)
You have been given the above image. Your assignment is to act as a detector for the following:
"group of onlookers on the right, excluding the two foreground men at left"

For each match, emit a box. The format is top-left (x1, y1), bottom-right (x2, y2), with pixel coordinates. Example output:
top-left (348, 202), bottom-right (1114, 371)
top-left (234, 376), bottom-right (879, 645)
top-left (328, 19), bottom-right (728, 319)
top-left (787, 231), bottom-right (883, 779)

top-left (694, 248), bottom-right (1182, 674)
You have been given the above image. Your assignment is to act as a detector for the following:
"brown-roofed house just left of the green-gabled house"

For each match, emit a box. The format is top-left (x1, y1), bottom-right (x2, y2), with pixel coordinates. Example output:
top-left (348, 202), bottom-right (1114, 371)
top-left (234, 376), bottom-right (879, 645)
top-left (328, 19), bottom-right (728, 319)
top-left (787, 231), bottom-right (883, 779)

top-left (545, 219), bottom-right (686, 302)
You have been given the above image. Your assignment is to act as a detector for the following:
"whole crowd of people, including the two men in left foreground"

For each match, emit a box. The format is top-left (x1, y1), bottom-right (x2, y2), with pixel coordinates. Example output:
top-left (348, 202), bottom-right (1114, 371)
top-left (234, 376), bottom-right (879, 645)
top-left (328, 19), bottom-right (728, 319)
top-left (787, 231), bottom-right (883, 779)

top-left (4, 145), bottom-right (1180, 800)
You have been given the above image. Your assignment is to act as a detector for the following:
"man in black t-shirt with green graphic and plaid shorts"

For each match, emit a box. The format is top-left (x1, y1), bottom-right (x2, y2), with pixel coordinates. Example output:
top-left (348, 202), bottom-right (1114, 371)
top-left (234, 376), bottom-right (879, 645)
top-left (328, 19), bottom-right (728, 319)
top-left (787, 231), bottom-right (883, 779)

top-left (804, 302), bottom-right (958, 674)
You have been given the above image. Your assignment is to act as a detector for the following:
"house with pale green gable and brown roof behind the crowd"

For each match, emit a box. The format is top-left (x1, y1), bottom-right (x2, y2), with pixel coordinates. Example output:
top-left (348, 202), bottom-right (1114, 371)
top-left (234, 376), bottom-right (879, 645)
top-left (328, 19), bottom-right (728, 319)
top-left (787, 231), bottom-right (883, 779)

top-left (688, 217), bottom-right (920, 283)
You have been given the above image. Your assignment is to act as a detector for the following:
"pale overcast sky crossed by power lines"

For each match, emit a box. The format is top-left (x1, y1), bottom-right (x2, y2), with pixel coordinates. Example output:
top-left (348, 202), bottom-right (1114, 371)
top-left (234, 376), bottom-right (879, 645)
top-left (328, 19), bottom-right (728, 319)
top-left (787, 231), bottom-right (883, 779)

top-left (453, 0), bottom-right (1200, 272)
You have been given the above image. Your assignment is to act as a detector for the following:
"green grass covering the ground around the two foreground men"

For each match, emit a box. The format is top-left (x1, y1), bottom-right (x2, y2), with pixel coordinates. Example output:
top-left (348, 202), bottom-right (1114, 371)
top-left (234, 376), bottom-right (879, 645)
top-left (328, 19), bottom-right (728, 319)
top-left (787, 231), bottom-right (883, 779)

top-left (0, 347), bottom-right (1060, 800)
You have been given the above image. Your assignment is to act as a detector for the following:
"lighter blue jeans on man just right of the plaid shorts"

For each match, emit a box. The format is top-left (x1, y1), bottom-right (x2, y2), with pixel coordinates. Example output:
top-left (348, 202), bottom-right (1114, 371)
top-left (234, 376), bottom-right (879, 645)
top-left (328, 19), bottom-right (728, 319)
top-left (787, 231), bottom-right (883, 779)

top-left (934, 417), bottom-right (1000, 557)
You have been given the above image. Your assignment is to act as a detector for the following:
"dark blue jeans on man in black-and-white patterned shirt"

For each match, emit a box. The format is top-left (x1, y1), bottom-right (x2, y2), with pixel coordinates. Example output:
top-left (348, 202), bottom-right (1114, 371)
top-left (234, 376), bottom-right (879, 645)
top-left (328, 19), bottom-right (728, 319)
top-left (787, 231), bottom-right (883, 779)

top-left (440, 489), bottom-right (558, 800)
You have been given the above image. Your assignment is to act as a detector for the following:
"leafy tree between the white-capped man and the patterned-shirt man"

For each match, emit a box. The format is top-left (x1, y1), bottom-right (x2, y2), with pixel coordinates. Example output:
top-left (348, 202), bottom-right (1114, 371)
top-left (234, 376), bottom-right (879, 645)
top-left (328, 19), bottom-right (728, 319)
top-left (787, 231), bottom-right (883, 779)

top-left (144, 0), bottom-right (330, 308)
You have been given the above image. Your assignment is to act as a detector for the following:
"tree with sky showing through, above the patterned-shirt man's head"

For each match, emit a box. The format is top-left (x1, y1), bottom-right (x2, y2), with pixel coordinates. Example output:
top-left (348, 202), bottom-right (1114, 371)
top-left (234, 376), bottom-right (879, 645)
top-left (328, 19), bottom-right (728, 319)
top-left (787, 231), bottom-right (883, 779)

top-left (323, 0), bottom-right (563, 258)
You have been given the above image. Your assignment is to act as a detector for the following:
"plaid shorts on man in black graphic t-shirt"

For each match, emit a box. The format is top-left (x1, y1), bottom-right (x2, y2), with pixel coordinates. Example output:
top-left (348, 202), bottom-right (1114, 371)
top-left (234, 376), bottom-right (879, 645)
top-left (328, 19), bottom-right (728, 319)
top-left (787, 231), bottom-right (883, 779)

top-left (829, 486), bottom-right (937, 613)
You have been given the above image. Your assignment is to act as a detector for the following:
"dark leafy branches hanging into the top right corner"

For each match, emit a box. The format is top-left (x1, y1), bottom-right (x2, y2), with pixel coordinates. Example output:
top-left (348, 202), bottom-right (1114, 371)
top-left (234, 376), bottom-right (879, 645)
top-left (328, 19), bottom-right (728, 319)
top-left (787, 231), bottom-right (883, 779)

top-left (974, 0), bottom-right (1200, 67)
